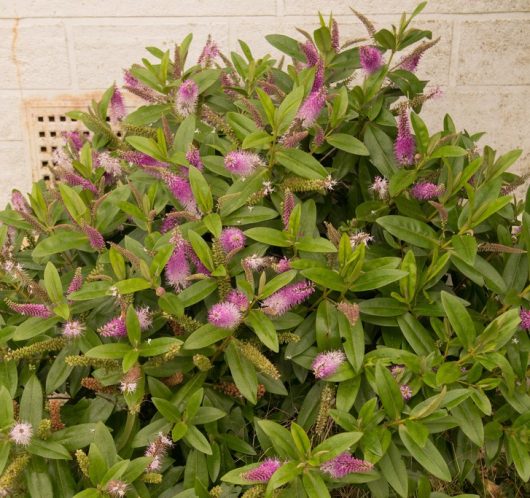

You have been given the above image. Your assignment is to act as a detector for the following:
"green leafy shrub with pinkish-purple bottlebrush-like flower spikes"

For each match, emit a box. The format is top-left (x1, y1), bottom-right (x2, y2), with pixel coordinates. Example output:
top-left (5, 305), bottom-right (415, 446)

top-left (0, 4), bottom-right (530, 498)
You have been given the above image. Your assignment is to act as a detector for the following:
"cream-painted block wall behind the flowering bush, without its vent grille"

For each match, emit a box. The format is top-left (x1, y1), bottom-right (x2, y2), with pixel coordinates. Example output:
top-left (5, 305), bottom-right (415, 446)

top-left (0, 0), bottom-right (530, 206)
